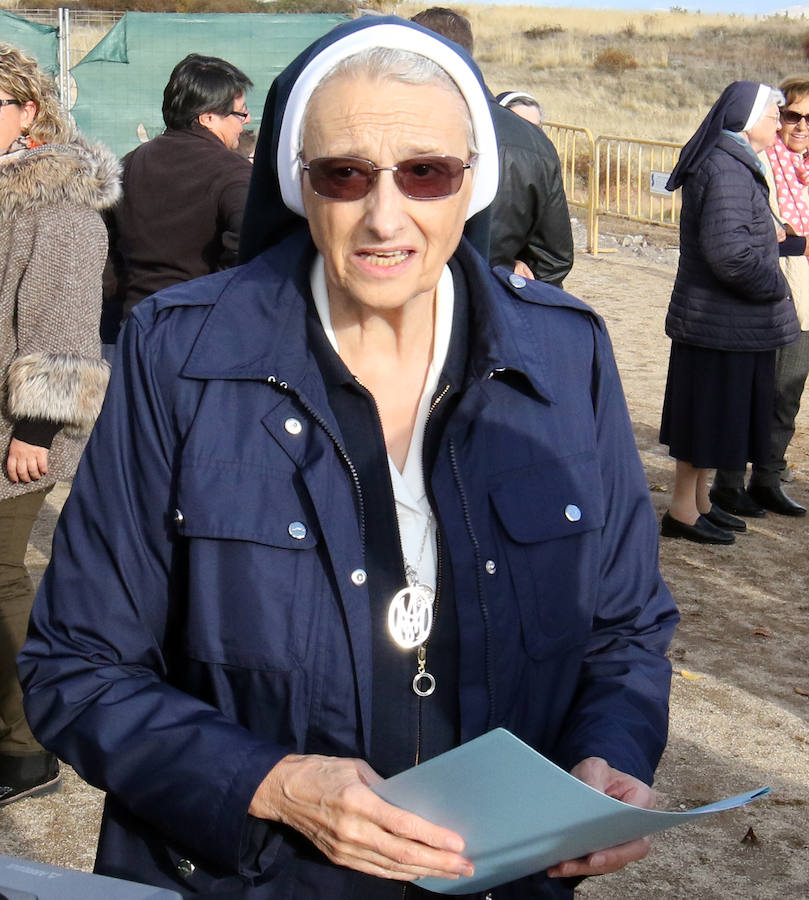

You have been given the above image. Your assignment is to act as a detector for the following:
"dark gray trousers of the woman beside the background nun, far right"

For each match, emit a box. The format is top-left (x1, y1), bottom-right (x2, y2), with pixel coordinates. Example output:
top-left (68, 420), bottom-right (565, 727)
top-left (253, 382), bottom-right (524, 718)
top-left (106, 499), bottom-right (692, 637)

top-left (714, 331), bottom-right (809, 488)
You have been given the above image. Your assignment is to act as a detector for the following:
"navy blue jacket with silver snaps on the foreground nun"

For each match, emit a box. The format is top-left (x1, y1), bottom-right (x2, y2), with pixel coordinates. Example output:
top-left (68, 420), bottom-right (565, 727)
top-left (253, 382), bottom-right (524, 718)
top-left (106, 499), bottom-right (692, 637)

top-left (20, 234), bottom-right (677, 900)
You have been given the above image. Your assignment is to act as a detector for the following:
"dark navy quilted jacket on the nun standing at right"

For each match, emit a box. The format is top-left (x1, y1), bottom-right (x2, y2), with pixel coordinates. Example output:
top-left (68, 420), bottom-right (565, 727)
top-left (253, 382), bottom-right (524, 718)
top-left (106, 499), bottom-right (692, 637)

top-left (666, 134), bottom-right (799, 350)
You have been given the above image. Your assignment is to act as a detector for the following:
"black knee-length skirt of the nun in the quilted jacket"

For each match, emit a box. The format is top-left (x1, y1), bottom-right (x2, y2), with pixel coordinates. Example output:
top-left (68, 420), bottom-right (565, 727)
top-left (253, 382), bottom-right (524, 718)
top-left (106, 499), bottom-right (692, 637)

top-left (660, 341), bottom-right (775, 471)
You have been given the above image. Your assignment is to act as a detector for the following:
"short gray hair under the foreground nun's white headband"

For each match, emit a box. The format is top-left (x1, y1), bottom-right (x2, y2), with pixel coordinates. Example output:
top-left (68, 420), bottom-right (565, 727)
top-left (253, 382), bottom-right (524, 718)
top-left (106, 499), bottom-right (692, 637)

top-left (298, 47), bottom-right (478, 155)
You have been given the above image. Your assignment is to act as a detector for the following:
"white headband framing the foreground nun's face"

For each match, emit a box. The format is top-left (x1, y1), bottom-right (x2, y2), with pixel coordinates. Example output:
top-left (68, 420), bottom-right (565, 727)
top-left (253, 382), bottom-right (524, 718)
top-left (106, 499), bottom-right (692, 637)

top-left (278, 24), bottom-right (499, 218)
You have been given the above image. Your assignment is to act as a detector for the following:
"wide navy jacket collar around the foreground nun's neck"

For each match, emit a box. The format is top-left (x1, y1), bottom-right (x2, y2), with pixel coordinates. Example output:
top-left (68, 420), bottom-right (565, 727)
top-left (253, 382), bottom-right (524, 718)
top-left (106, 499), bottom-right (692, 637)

top-left (183, 229), bottom-right (576, 400)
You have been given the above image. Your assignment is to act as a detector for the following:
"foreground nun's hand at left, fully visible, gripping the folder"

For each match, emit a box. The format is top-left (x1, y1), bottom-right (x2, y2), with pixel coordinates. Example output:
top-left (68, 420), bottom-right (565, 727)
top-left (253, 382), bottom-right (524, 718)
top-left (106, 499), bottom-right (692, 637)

top-left (249, 755), bottom-right (474, 881)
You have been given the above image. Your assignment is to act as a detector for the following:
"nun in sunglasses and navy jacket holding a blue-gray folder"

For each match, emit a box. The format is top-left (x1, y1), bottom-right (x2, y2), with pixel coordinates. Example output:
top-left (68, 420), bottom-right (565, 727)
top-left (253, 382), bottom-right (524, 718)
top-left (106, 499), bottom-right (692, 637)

top-left (20, 17), bottom-right (677, 900)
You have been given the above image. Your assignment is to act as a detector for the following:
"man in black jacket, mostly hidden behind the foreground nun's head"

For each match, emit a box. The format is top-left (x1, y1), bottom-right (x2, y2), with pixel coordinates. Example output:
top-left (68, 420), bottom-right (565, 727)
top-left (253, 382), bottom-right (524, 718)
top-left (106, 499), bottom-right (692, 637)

top-left (413, 6), bottom-right (573, 287)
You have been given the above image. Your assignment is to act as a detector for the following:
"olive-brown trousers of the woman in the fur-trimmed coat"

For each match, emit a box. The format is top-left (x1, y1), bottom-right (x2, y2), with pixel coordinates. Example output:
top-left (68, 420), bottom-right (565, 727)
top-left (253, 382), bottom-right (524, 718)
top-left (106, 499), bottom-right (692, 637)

top-left (0, 488), bottom-right (50, 756)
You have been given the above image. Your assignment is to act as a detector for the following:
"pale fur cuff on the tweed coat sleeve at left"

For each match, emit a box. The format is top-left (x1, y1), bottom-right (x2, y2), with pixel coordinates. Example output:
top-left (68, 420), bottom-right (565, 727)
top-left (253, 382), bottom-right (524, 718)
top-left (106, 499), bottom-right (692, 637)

top-left (5, 353), bottom-right (109, 435)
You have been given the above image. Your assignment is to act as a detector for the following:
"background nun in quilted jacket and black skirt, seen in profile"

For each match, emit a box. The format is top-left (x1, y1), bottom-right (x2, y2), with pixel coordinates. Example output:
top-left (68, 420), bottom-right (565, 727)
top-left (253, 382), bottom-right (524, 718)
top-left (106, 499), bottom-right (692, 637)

top-left (660, 81), bottom-right (799, 544)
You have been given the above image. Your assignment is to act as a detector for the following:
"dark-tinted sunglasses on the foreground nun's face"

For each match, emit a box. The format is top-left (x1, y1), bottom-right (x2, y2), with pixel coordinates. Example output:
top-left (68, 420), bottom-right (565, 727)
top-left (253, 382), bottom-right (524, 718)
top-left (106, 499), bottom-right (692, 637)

top-left (301, 156), bottom-right (474, 200)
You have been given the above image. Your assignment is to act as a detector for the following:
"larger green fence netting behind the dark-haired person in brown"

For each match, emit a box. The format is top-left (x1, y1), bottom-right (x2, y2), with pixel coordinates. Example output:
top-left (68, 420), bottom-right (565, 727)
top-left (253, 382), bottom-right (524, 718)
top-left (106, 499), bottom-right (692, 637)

top-left (71, 12), bottom-right (347, 155)
